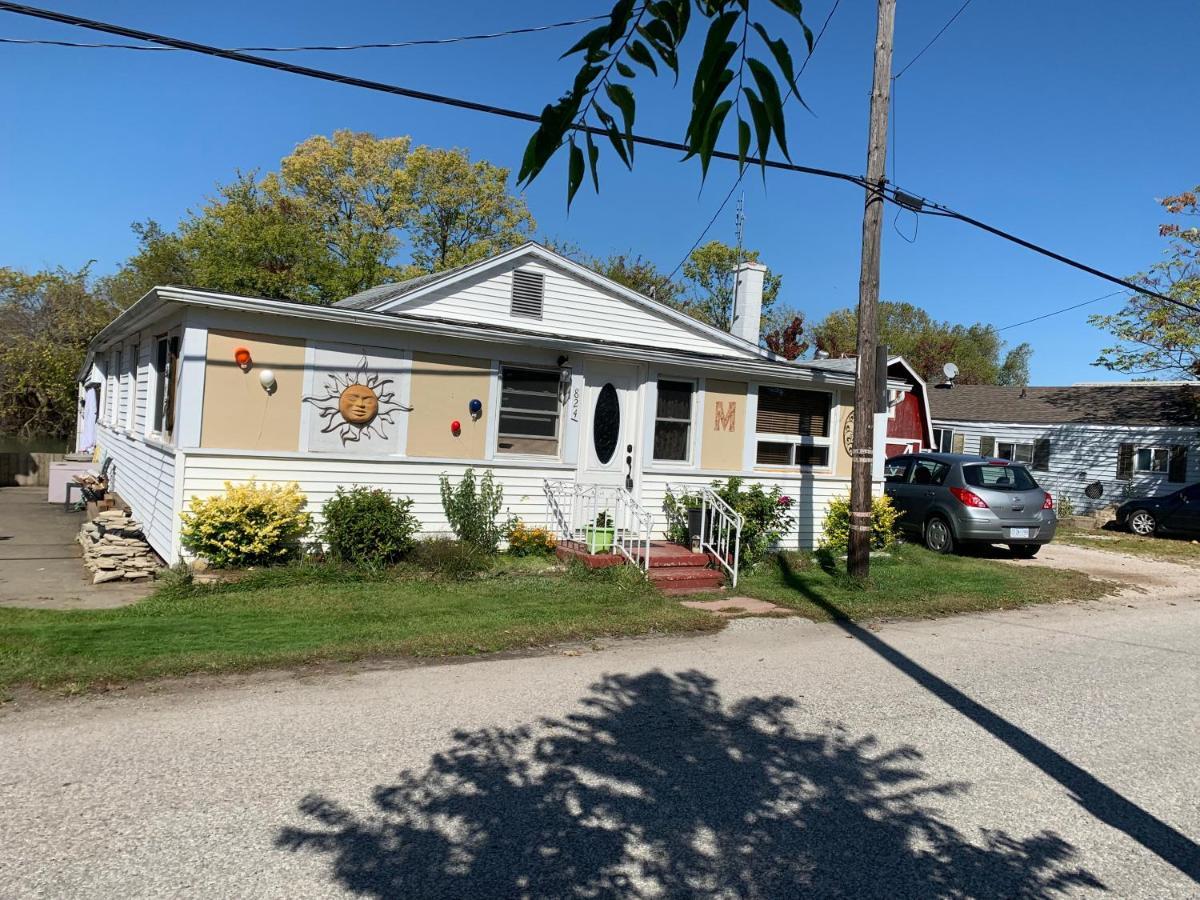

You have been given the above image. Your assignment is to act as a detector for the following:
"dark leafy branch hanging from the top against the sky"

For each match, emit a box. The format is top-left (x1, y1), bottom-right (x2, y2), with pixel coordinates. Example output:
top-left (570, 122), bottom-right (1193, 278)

top-left (518, 0), bottom-right (812, 206)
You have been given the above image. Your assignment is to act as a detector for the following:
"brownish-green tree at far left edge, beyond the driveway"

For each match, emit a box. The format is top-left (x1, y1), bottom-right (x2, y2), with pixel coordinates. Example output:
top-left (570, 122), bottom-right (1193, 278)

top-left (0, 264), bottom-right (120, 437)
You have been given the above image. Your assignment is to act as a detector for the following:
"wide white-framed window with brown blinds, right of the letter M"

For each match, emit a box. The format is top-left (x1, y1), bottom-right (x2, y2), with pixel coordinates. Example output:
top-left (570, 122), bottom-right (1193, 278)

top-left (755, 385), bottom-right (833, 468)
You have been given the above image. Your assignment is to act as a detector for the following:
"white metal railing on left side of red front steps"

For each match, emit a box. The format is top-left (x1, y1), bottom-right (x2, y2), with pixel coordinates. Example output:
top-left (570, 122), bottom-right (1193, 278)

top-left (542, 479), bottom-right (654, 571)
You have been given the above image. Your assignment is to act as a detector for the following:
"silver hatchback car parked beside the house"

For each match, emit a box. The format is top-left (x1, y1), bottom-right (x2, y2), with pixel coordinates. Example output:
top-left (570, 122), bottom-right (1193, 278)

top-left (883, 454), bottom-right (1058, 557)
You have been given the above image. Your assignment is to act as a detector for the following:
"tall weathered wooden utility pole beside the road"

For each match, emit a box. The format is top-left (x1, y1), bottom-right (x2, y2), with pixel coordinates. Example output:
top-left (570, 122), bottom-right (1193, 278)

top-left (846, 0), bottom-right (896, 578)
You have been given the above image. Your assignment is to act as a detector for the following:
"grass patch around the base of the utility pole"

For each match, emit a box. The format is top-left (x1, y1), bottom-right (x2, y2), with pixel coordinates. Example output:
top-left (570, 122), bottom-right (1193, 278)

top-left (737, 545), bottom-right (1109, 622)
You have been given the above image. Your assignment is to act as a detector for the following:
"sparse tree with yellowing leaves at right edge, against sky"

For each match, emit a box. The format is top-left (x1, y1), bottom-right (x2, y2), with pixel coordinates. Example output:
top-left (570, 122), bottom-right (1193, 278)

top-left (1088, 185), bottom-right (1200, 379)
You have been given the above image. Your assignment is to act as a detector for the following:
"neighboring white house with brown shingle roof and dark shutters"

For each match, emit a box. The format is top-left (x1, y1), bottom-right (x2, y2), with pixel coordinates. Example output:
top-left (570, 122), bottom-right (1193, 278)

top-left (929, 382), bottom-right (1200, 512)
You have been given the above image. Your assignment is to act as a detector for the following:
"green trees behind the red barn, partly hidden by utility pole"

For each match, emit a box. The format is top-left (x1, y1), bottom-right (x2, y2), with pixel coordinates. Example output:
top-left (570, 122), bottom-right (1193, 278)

top-left (812, 300), bottom-right (1033, 384)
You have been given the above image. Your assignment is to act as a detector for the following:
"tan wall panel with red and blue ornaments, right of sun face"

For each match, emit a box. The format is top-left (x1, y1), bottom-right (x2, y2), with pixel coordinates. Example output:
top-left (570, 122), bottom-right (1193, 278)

top-left (406, 353), bottom-right (492, 460)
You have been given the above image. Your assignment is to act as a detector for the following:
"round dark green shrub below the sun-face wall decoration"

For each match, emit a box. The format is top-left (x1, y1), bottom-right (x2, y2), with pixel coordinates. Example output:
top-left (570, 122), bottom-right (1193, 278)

top-left (322, 487), bottom-right (421, 568)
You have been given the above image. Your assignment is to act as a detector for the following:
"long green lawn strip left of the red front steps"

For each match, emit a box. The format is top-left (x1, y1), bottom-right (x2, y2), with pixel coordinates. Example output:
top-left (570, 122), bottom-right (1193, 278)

top-left (0, 559), bottom-right (720, 690)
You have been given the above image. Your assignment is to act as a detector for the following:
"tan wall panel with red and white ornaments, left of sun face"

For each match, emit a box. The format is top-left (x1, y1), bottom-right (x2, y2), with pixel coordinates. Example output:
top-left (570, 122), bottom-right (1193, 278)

top-left (200, 331), bottom-right (305, 450)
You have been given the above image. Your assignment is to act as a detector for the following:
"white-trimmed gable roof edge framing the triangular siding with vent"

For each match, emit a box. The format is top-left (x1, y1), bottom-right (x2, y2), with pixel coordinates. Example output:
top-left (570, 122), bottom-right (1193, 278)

top-left (334, 241), bottom-right (763, 365)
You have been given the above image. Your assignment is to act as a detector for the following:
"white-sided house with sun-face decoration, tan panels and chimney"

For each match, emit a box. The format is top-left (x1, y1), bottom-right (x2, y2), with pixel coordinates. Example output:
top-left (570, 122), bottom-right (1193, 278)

top-left (72, 242), bottom-right (911, 563)
